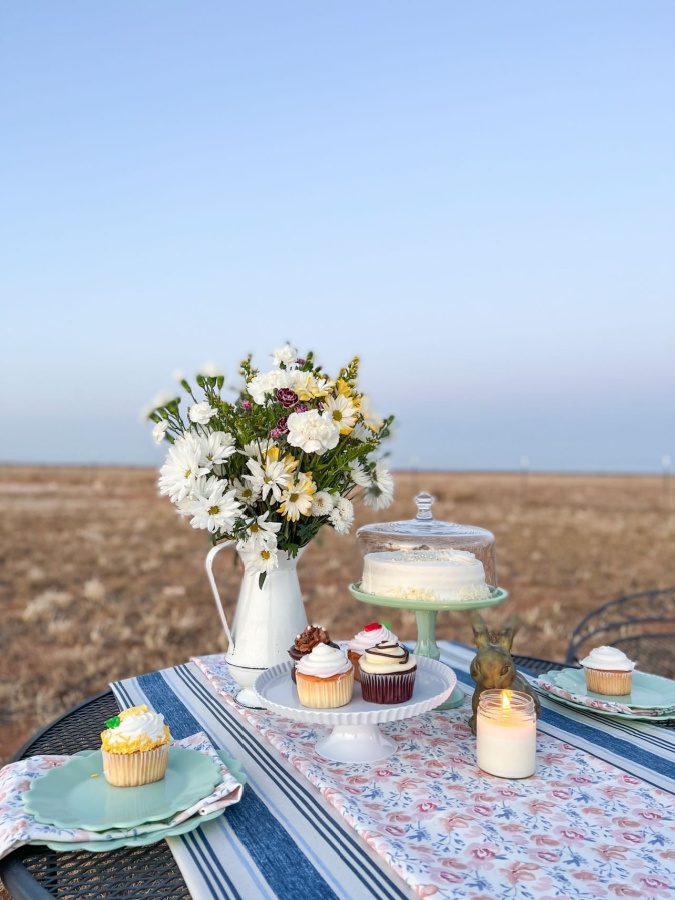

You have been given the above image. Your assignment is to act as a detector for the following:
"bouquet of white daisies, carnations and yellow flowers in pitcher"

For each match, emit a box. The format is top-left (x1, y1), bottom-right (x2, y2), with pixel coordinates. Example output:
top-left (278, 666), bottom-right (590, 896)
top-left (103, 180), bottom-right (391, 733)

top-left (148, 344), bottom-right (393, 588)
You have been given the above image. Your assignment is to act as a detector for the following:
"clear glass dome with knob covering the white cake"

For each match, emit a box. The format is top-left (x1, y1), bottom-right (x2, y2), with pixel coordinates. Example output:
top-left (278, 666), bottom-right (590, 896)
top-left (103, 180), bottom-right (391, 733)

top-left (356, 491), bottom-right (498, 587)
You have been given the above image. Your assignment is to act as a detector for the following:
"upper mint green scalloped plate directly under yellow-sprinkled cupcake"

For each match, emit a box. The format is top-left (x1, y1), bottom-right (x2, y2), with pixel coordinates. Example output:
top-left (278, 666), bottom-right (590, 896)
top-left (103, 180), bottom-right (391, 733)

top-left (23, 747), bottom-right (220, 831)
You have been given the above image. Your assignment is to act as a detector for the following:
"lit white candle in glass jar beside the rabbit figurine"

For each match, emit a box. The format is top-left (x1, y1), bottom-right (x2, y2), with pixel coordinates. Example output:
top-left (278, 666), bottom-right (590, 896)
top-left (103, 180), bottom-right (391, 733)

top-left (476, 691), bottom-right (537, 778)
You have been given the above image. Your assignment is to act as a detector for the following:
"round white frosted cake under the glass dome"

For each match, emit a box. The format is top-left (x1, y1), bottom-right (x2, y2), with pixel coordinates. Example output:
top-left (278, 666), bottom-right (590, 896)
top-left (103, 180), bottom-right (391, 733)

top-left (361, 550), bottom-right (490, 603)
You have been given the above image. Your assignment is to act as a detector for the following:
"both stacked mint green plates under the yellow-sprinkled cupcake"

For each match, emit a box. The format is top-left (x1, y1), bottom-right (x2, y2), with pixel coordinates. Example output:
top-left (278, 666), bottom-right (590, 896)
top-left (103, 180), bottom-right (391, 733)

top-left (22, 747), bottom-right (246, 852)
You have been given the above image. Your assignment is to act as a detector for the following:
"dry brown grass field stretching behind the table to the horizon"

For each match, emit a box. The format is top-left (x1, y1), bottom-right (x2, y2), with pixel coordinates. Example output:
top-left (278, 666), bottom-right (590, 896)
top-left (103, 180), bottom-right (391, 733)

top-left (0, 467), bottom-right (675, 762)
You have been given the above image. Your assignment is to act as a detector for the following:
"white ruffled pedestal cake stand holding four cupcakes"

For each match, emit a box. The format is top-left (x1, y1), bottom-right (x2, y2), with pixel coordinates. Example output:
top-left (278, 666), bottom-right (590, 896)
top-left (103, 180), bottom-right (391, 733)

top-left (254, 657), bottom-right (457, 763)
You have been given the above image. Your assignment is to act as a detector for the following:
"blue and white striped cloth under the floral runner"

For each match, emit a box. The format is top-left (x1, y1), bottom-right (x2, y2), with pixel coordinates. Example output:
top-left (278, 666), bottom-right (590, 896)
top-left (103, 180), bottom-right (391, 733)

top-left (112, 642), bottom-right (675, 900)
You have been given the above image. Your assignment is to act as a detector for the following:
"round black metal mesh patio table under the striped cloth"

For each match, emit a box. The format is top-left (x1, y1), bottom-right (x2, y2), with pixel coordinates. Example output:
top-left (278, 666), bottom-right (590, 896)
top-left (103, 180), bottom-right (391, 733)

top-left (0, 656), bottom-right (564, 900)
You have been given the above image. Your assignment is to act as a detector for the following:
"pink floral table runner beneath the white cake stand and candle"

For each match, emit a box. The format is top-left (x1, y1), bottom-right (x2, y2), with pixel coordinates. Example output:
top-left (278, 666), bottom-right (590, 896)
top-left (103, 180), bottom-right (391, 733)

top-left (193, 655), bottom-right (675, 898)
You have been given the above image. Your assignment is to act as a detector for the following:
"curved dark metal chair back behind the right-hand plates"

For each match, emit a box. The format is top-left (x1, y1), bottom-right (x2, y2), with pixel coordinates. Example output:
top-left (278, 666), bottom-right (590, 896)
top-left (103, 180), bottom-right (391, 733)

top-left (566, 588), bottom-right (675, 678)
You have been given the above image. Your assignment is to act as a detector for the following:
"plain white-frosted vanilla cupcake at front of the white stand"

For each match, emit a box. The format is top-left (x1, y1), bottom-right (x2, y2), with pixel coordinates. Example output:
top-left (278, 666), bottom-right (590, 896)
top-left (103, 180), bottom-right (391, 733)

top-left (295, 644), bottom-right (354, 709)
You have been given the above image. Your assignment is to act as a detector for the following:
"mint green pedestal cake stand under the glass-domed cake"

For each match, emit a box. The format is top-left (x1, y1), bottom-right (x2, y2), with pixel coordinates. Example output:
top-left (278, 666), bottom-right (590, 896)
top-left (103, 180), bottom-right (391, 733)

top-left (349, 581), bottom-right (509, 709)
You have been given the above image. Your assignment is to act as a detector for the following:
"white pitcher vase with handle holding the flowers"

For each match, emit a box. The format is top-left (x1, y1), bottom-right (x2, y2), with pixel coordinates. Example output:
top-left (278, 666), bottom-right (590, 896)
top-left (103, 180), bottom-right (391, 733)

top-left (206, 541), bottom-right (307, 709)
